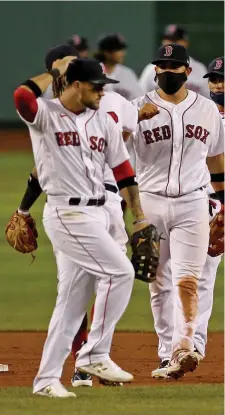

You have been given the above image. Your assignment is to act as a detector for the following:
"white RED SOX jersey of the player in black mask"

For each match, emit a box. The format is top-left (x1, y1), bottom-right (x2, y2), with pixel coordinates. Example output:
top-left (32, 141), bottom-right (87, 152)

top-left (133, 91), bottom-right (224, 197)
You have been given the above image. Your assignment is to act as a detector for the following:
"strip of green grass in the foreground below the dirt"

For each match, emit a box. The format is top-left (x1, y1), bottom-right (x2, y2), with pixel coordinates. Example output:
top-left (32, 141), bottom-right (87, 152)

top-left (0, 385), bottom-right (223, 415)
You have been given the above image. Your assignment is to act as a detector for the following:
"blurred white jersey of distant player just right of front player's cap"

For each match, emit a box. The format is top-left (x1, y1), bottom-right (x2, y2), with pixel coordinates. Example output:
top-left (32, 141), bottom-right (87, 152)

top-left (105, 64), bottom-right (144, 101)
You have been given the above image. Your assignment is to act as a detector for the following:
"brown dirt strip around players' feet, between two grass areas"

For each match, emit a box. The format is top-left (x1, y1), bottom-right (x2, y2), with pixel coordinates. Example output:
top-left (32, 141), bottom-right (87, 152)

top-left (0, 332), bottom-right (224, 387)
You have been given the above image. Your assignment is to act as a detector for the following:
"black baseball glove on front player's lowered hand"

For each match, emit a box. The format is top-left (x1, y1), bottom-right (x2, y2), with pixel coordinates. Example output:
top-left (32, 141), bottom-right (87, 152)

top-left (131, 225), bottom-right (161, 283)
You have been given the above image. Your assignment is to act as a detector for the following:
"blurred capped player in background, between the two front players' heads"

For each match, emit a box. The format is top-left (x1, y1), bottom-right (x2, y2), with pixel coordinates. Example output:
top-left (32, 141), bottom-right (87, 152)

top-left (94, 33), bottom-right (144, 101)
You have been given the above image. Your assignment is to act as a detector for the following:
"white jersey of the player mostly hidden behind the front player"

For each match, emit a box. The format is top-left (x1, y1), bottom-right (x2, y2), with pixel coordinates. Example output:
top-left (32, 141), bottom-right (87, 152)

top-left (43, 85), bottom-right (138, 186)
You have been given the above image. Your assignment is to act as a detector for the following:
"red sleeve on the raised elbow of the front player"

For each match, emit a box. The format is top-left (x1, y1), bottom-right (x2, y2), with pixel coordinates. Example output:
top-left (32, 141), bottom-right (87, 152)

top-left (14, 86), bottom-right (38, 122)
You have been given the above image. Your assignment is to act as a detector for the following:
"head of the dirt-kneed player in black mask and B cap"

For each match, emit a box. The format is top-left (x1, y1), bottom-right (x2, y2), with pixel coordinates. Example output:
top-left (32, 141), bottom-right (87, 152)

top-left (152, 44), bottom-right (191, 99)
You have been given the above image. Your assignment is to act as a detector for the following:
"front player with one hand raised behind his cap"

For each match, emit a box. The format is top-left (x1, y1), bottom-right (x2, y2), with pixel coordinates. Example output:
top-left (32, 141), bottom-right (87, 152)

top-left (14, 57), bottom-right (158, 397)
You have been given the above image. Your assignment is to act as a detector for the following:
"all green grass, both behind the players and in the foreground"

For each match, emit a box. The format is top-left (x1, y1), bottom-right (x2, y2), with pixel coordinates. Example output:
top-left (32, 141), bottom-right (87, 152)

top-left (0, 153), bottom-right (224, 415)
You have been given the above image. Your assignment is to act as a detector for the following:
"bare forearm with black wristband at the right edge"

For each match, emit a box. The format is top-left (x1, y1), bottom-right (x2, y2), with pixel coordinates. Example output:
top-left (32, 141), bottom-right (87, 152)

top-left (207, 153), bottom-right (224, 192)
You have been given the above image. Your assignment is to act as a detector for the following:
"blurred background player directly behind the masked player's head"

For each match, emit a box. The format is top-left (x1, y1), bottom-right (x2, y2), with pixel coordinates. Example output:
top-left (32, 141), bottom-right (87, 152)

top-left (139, 24), bottom-right (209, 98)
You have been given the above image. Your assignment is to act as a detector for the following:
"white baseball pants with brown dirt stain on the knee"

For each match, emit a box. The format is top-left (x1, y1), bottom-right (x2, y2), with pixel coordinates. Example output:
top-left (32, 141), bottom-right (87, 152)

top-left (141, 189), bottom-right (209, 358)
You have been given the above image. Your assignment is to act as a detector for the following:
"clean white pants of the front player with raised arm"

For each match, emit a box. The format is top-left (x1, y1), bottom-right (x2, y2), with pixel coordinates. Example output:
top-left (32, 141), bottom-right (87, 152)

top-left (33, 200), bottom-right (134, 393)
